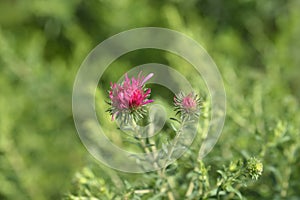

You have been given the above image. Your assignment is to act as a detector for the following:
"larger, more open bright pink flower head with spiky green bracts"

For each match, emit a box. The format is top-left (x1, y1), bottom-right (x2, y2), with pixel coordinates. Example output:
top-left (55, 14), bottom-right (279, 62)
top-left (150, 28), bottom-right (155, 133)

top-left (108, 72), bottom-right (153, 120)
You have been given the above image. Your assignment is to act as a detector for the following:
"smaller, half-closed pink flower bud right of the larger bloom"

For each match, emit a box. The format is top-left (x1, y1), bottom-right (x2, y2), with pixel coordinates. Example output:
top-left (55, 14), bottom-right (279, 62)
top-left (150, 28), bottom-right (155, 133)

top-left (174, 92), bottom-right (202, 117)
